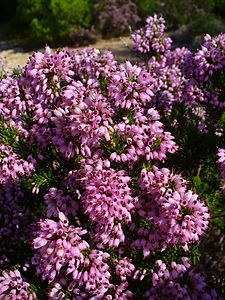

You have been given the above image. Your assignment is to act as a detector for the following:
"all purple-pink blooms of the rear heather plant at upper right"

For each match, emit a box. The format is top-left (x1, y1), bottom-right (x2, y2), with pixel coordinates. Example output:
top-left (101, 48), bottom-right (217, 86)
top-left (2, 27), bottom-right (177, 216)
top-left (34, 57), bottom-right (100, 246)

top-left (131, 15), bottom-right (225, 135)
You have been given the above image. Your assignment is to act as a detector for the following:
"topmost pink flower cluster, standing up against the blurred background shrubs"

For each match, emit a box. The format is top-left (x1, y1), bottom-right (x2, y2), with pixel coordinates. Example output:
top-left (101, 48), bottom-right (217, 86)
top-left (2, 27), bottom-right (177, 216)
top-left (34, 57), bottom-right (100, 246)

top-left (131, 15), bottom-right (172, 53)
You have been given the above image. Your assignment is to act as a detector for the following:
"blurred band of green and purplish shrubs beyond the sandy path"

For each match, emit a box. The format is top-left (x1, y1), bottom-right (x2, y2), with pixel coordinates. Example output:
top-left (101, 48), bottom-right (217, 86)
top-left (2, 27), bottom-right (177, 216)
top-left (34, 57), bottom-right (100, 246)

top-left (0, 0), bottom-right (225, 48)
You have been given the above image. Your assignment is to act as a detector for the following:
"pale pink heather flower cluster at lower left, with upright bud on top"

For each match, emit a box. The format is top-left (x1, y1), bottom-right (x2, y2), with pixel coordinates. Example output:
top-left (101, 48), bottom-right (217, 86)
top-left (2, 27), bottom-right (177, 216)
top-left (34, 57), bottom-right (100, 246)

top-left (32, 212), bottom-right (89, 282)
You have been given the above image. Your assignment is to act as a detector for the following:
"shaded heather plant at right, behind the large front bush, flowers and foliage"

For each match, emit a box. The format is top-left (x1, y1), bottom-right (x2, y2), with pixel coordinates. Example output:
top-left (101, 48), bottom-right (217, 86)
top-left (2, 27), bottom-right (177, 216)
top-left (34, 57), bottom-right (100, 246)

top-left (131, 16), bottom-right (225, 232)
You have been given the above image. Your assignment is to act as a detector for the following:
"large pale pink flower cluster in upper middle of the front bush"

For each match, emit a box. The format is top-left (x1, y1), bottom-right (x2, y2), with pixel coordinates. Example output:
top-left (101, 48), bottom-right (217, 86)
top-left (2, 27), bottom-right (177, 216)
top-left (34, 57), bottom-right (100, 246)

top-left (51, 82), bottom-right (113, 158)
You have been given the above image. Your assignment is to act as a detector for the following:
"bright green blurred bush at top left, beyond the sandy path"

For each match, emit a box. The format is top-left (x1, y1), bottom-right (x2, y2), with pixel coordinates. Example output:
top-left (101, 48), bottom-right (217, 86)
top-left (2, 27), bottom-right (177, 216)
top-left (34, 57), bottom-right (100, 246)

top-left (15, 0), bottom-right (92, 46)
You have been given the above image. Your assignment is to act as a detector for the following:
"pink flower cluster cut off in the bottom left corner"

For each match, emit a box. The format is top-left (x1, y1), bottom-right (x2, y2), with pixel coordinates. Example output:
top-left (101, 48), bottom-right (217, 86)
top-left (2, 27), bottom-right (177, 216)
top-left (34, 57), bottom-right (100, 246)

top-left (0, 270), bottom-right (36, 300)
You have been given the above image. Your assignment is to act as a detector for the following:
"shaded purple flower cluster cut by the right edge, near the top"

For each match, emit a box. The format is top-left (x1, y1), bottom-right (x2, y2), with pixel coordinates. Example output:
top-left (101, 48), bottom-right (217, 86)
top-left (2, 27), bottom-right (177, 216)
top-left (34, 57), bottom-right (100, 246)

top-left (182, 33), bottom-right (225, 108)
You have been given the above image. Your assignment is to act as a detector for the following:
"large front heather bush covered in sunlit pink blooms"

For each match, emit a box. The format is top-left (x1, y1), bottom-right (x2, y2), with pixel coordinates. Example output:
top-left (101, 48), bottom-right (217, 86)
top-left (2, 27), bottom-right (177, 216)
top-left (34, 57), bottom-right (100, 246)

top-left (0, 47), bottom-right (216, 300)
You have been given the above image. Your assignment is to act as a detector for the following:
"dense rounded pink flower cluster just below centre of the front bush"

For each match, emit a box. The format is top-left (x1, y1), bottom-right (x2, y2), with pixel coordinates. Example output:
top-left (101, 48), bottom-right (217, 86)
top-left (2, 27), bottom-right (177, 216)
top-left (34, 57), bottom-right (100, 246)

top-left (81, 169), bottom-right (136, 224)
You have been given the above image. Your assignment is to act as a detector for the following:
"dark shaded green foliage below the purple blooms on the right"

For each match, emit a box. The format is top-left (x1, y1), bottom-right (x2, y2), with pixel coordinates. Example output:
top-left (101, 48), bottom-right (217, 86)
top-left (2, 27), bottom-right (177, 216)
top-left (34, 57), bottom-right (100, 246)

top-left (164, 102), bottom-right (225, 230)
